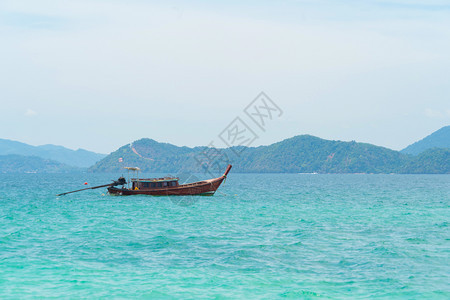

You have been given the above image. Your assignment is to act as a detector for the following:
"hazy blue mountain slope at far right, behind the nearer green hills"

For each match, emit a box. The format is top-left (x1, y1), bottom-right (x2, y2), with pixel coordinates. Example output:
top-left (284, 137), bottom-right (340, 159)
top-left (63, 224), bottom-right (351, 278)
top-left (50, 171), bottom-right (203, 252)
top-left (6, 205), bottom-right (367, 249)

top-left (401, 126), bottom-right (450, 155)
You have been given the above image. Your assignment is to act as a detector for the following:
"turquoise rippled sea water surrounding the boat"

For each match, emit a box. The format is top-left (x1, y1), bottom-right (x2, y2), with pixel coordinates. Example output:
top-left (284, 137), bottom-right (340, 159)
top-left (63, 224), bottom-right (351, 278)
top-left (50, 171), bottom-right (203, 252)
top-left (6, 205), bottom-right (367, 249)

top-left (0, 173), bottom-right (450, 299)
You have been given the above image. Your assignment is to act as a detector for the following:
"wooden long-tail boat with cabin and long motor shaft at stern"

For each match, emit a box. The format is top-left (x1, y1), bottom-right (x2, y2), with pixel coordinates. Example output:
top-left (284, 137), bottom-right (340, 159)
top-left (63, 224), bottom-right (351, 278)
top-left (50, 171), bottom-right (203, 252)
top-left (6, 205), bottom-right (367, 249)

top-left (57, 165), bottom-right (231, 196)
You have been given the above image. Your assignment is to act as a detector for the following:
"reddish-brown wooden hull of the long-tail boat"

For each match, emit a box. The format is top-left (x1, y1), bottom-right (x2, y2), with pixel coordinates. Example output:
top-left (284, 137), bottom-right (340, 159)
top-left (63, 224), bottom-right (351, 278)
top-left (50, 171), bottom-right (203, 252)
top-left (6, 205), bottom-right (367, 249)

top-left (108, 172), bottom-right (228, 196)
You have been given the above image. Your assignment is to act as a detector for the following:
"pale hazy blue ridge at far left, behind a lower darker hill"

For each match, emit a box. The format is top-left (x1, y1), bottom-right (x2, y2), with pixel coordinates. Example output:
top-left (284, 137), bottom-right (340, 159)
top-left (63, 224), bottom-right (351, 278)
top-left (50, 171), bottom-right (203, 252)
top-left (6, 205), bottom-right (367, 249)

top-left (0, 139), bottom-right (106, 168)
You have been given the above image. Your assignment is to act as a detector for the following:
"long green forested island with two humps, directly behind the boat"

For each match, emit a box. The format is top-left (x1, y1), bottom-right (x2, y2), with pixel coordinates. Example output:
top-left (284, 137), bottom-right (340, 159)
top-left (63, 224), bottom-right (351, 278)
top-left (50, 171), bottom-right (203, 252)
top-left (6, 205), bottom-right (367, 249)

top-left (89, 135), bottom-right (450, 173)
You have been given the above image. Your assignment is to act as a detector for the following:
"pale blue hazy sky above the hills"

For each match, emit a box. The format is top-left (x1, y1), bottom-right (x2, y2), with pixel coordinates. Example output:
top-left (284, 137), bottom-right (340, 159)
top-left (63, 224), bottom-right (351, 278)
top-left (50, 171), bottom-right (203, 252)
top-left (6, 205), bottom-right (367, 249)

top-left (0, 0), bottom-right (450, 153)
